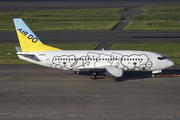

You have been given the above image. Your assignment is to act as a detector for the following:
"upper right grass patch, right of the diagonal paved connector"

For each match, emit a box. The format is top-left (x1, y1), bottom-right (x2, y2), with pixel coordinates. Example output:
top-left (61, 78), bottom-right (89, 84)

top-left (124, 6), bottom-right (180, 30)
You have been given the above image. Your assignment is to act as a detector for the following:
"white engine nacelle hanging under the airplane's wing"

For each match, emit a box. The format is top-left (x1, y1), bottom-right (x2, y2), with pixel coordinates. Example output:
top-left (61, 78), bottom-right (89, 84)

top-left (105, 68), bottom-right (124, 78)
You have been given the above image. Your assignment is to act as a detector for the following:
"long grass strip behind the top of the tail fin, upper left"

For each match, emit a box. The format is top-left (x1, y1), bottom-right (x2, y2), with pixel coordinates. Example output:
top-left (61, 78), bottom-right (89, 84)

top-left (0, 8), bottom-right (126, 31)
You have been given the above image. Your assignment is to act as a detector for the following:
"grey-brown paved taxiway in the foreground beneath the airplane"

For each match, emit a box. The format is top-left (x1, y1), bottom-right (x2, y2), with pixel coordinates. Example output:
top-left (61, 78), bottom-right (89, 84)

top-left (0, 66), bottom-right (180, 120)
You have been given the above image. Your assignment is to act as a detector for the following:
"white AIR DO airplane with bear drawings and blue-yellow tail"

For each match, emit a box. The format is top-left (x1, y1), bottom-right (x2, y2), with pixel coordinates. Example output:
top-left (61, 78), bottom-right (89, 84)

top-left (13, 18), bottom-right (174, 79)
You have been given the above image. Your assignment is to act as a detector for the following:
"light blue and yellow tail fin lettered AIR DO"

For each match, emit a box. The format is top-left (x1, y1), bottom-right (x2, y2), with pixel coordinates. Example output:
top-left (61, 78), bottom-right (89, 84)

top-left (13, 18), bottom-right (61, 52)
